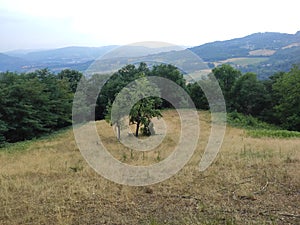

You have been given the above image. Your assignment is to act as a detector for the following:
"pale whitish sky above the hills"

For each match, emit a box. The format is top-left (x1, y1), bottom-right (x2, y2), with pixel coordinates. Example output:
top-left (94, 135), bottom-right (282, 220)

top-left (0, 0), bottom-right (300, 52)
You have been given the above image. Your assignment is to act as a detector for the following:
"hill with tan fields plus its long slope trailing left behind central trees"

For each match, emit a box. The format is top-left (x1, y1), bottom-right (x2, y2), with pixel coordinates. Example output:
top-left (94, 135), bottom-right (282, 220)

top-left (86, 32), bottom-right (300, 79)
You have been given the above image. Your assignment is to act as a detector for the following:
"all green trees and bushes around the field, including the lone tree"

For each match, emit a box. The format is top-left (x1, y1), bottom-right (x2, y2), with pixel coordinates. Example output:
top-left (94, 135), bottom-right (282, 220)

top-left (0, 58), bottom-right (300, 145)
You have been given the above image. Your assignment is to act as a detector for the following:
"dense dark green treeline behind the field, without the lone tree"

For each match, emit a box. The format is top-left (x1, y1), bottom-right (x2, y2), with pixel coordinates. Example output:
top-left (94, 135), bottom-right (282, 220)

top-left (0, 63), bottom-right (300, 144)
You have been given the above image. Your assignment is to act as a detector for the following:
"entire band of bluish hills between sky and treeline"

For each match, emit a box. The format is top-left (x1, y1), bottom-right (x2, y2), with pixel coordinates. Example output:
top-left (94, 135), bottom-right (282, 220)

top-left (0, 31), bottom-right (300, 79)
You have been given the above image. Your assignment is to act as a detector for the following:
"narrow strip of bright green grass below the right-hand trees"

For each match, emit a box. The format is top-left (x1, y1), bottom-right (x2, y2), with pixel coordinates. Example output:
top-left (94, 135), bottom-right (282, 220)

top-left (247, 129), bottom-right (300, 138)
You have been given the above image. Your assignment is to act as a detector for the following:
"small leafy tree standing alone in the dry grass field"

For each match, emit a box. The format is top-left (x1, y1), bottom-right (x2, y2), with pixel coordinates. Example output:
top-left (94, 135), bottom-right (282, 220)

top-left (106, 64), bottom-right (162, 140)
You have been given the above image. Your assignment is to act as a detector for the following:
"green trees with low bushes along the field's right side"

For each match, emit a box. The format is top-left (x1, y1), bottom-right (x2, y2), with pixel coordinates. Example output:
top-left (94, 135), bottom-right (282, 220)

top-left (204, 65), bottom-right (300, 131)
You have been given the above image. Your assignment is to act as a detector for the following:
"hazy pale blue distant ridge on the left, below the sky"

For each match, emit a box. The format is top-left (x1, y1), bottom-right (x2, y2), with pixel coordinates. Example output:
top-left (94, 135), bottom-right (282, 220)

top-left (0, 45), bottom-right (181, 72)
